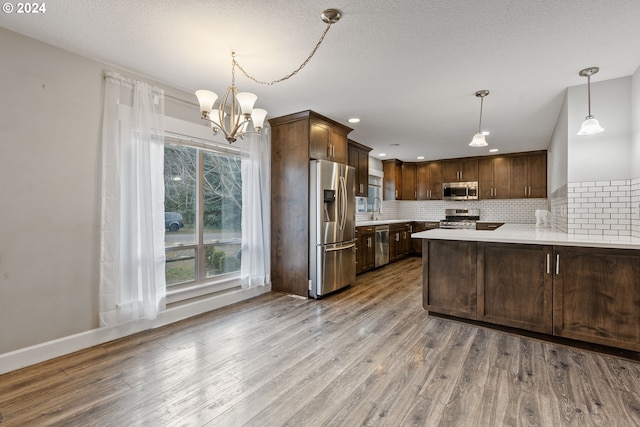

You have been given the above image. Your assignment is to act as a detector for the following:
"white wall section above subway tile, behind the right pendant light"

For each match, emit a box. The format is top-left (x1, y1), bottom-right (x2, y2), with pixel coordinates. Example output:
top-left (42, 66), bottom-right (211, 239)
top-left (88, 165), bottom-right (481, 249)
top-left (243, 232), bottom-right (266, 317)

top-left (567, 74), bottom-right (632, 182)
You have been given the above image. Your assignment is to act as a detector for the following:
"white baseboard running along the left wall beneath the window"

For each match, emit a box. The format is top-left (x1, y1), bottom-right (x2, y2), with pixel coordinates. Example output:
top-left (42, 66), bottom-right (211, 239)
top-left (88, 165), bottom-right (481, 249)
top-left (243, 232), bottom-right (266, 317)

top-left (0, 285), bottom-right (271, 374)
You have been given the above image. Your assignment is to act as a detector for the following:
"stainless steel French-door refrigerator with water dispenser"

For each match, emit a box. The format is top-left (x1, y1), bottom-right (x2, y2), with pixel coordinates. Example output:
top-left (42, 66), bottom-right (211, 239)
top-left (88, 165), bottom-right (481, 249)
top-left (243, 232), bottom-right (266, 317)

top-left (308, 160), bottom-right (356, 298)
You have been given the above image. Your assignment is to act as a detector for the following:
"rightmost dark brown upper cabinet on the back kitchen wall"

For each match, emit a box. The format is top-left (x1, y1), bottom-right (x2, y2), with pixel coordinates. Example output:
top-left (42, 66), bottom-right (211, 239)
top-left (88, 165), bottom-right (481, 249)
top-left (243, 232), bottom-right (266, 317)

top-left (511, 152), bottom-right (547, 199)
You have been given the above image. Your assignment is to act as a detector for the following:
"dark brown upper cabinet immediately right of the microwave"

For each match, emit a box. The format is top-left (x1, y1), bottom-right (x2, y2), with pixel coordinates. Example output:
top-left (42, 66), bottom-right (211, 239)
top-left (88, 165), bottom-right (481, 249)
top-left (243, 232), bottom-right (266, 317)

top-left (478, 156), bottom-right (511, 199)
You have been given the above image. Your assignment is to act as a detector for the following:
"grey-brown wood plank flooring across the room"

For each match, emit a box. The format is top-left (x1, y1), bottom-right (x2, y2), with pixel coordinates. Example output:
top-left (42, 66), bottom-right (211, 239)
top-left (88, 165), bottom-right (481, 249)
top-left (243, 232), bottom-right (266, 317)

top-left (0, 258), bottom-right (640, 426)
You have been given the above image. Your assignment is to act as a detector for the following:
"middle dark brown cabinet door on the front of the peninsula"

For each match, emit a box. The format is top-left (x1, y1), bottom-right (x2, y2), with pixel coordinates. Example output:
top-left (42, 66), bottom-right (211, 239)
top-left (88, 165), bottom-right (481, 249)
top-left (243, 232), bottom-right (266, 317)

top-left (478, 243), bottom-right (553, 334)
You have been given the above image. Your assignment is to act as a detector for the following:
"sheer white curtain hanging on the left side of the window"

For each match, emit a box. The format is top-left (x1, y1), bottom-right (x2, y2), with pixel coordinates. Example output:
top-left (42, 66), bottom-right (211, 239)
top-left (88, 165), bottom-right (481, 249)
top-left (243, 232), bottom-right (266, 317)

top-left (100, 72), bottom-right (166, 326)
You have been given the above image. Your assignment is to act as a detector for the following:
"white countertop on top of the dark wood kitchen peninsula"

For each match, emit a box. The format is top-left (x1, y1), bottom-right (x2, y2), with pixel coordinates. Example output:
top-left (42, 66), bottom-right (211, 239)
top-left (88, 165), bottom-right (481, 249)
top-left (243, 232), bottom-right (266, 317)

top-left (411, 224), bottom-right (640, 249)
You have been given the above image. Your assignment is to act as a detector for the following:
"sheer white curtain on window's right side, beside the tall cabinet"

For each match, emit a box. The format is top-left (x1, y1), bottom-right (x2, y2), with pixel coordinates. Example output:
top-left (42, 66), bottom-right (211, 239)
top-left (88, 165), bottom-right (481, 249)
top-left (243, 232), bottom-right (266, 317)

top-left (240, 126), bottom-right (271, 288)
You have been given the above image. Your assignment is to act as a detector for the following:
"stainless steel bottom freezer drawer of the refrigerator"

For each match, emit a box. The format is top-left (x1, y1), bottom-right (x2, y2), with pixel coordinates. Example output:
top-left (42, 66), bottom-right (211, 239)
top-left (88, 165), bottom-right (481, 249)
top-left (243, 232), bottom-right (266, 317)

top-left (309, 240), bottom-right (356, 298)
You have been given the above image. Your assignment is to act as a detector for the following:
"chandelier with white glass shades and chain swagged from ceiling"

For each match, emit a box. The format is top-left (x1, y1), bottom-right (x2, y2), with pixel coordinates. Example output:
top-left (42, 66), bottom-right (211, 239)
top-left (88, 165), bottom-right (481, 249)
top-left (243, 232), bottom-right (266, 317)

top-left (196, 9), bottom-right (341, 144)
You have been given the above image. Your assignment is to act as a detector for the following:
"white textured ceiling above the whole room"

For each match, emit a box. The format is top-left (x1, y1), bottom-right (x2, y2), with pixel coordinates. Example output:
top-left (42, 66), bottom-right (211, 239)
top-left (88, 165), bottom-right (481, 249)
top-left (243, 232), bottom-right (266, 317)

top-left (1, 0), bottom-right (640, 160)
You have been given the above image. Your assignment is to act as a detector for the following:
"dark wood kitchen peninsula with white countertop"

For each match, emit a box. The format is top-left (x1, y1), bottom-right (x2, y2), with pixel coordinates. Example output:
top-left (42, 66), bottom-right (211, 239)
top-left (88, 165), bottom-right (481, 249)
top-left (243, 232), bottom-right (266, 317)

top-left (411, 224), bottom-right (640, 352)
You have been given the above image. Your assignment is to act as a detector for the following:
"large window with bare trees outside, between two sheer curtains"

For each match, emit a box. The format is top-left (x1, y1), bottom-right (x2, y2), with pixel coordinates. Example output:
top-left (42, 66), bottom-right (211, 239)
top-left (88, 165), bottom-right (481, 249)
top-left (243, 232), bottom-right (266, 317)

top-left (164, 143), bottom-right (242, 298)
